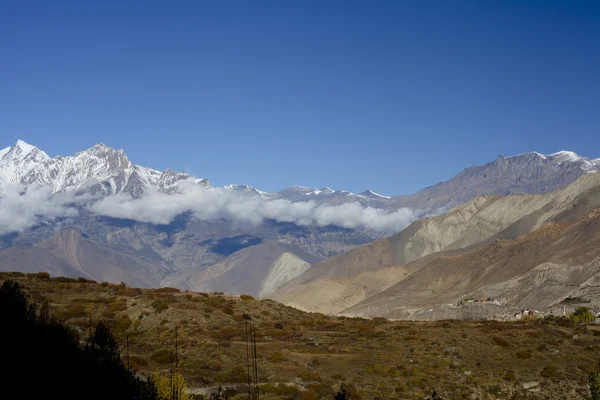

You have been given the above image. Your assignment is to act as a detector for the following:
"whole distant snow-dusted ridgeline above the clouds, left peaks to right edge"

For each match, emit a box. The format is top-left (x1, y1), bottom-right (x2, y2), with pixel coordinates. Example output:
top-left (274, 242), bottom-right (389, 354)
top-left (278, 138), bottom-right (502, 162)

top-left (0, 140), bottom-right (600, 210)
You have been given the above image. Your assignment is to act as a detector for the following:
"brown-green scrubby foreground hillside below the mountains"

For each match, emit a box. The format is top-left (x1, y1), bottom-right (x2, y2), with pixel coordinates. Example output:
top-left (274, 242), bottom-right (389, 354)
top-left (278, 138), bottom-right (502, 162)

top-left (0, 273), bottom-right (600, 399)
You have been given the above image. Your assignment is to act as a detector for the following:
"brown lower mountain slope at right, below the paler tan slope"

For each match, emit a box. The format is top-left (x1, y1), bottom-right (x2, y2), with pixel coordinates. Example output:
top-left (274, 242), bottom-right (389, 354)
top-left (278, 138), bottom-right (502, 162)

top-left (345, 209), bottom-right (600, 319)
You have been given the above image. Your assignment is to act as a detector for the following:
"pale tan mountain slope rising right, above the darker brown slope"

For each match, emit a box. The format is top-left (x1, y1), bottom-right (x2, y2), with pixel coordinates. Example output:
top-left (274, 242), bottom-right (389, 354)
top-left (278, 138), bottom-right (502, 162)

top-left (270, 174), bottom-right (600, 312)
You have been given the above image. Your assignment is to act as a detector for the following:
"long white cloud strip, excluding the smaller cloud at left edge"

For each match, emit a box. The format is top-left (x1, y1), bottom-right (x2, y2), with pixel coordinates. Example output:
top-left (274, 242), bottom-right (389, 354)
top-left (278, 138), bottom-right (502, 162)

top-left (89, 183), bottom-right (416, 232)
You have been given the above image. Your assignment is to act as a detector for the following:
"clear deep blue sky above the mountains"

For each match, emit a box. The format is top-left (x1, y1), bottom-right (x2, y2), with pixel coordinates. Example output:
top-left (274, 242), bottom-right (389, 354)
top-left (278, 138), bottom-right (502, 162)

top-left (0, 0), bottom-right (600, 194)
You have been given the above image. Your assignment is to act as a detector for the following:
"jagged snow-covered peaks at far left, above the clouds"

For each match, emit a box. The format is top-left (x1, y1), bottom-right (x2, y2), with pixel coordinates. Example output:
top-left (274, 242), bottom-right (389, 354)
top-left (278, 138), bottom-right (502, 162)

top-left (0, 140), bottom-right (209, 197)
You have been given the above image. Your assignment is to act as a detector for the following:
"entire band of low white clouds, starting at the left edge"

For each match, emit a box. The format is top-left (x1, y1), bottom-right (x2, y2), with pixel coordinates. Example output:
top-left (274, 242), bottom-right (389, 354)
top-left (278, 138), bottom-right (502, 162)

top-left (0, 182), bottom-right (416, 234)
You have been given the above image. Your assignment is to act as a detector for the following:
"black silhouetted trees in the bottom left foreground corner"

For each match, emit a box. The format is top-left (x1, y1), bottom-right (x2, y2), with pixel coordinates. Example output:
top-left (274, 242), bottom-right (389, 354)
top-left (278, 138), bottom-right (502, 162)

top-left (0, 280), bottom-right (157, 400)
